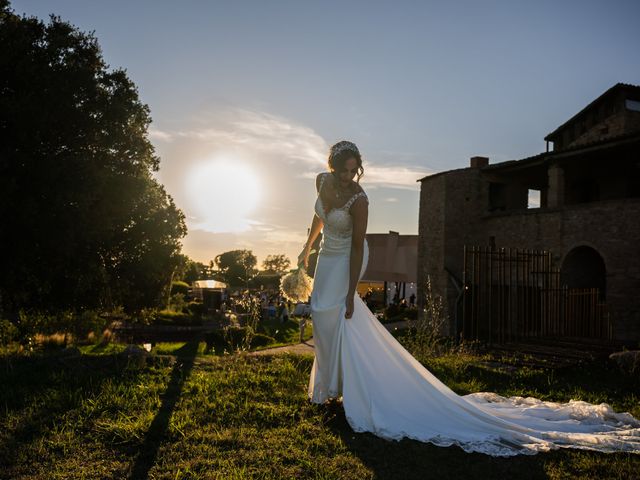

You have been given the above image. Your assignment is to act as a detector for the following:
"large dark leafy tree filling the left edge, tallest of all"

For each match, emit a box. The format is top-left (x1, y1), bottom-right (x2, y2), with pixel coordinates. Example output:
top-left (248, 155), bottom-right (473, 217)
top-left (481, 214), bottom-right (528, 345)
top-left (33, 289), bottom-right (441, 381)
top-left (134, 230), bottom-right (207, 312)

top-left (0, 4), bottom-right (186, 318)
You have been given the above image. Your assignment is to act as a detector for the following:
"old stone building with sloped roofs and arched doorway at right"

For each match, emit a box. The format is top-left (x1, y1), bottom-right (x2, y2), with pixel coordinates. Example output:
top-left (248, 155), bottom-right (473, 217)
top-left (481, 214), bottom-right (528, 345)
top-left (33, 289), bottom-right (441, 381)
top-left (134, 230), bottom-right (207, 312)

top-left (417, 83), bottom-right (640, 346)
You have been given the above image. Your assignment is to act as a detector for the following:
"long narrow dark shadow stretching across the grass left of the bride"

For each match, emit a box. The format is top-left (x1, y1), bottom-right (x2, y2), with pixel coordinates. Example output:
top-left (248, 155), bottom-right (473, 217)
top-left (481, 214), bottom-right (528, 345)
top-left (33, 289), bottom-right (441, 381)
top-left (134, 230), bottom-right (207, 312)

top-left (129, 341), bottom-right (199, 480)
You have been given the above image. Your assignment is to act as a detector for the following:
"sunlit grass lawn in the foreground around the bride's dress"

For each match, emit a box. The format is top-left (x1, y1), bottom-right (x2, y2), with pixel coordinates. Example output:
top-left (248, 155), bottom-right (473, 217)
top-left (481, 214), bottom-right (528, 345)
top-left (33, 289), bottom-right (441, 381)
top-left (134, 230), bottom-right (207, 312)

top-left (0, 344), bottom-right (640, 479)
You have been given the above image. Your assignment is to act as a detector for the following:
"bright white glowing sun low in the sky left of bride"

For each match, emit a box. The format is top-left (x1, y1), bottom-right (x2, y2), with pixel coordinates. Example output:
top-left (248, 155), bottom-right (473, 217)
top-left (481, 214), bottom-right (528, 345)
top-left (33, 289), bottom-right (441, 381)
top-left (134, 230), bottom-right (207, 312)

top-left (186, 159), bottom-right (261, 233)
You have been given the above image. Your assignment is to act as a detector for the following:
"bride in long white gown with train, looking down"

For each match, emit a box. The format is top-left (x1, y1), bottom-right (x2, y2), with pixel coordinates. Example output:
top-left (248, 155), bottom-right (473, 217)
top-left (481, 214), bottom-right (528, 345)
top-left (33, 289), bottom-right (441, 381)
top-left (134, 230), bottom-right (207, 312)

top-left (298, 141), bottom-right (640, 456)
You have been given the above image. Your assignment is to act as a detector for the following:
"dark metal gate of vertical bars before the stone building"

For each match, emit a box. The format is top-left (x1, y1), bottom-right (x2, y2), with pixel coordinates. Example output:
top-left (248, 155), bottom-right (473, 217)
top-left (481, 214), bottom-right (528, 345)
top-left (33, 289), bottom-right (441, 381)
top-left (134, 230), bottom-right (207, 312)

top-left (460, 246), bottom-right (612, 343)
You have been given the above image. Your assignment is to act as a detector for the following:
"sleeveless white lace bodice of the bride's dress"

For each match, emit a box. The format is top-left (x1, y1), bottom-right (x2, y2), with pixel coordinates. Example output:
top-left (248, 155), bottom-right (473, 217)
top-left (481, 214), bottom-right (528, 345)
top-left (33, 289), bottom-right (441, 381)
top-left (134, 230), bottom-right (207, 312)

top-left (315, 173), bottom-right (369, 255)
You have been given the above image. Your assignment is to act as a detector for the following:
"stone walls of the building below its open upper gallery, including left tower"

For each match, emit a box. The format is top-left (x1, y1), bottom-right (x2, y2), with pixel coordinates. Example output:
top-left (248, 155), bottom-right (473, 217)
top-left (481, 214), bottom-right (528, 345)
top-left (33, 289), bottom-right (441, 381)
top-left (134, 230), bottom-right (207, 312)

top-left (417, 168), bottom-right (640, 341)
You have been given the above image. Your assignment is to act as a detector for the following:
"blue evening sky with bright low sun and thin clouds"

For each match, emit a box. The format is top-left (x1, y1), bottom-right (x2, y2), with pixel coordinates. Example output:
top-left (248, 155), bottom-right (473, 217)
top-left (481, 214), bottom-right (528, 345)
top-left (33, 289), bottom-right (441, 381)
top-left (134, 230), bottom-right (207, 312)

top-left (11, 0), bottom-right (640, 266)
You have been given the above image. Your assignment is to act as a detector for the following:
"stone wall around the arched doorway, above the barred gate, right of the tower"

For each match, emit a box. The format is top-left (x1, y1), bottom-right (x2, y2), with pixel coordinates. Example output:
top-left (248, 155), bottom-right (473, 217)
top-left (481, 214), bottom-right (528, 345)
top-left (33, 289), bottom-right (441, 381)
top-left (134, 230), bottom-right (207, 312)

top-left (482, 199), bottom-right (640, 341)
